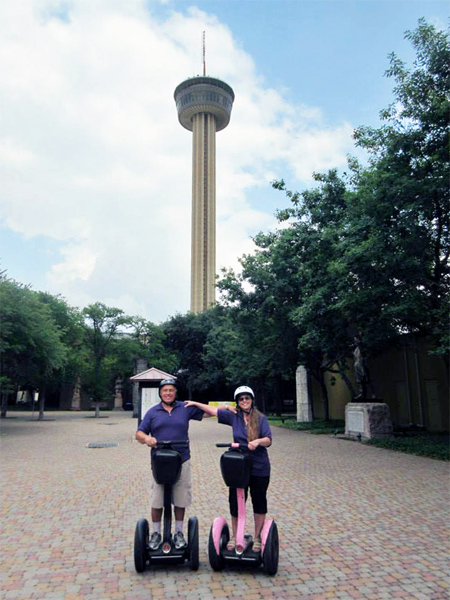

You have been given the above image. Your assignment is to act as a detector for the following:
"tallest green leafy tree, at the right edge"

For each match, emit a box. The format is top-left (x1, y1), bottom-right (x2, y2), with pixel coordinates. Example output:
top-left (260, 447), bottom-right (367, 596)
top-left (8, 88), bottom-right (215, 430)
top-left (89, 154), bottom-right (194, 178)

top-left (353, 19), bottom-right (450, 356)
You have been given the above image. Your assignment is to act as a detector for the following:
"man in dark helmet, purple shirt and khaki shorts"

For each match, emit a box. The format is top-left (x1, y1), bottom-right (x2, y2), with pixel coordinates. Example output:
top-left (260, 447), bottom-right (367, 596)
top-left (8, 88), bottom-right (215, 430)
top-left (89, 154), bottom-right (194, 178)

top-left (136, 378), bottom-right (203, 550)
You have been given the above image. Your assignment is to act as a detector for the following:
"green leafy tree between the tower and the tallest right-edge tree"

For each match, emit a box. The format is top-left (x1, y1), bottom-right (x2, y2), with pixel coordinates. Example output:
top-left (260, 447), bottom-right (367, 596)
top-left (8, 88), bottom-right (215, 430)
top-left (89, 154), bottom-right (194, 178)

top-left (219, 171), bottom-right (348, 417)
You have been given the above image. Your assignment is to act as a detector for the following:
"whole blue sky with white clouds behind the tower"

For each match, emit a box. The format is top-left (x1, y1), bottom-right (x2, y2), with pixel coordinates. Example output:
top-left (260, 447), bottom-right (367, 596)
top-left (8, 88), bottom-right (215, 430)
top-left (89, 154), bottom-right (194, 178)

top-left (0, 0), bottom-right (449, 323)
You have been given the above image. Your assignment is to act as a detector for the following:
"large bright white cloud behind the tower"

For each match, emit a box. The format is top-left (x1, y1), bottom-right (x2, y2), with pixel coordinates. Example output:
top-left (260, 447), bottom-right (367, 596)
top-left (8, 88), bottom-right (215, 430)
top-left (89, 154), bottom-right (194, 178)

top-left (0, 0), bottom-right (358, 321)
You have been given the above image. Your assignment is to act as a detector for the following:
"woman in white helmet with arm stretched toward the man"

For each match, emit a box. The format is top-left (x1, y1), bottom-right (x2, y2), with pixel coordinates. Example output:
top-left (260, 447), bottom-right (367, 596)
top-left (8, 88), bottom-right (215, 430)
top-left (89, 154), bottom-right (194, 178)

top-left (184, 385), bottom-right (272, 552)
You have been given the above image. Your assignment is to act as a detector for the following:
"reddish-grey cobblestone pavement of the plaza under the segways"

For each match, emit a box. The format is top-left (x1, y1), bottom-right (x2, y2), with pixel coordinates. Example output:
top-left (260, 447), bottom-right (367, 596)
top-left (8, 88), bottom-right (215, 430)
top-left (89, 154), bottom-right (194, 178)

top-left (0, 412), bottom-right (450, 600)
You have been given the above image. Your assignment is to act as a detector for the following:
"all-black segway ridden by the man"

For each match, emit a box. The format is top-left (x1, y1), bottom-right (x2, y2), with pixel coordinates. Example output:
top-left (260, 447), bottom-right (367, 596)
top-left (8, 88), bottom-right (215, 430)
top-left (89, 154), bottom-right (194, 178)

top-left (134, 441), bottom-right (199, 573)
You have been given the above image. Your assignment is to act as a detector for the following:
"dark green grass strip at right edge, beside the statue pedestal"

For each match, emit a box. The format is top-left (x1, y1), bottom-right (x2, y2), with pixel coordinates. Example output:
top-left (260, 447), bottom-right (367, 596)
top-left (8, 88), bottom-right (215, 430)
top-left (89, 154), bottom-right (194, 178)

top-left (364, 432), bottom-right (450, 460)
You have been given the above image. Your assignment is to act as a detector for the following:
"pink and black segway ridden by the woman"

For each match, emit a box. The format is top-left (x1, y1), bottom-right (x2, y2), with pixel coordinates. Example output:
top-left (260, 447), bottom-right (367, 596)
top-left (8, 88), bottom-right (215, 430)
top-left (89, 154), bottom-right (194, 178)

top-left (208, 443), bottom-right (278, 575)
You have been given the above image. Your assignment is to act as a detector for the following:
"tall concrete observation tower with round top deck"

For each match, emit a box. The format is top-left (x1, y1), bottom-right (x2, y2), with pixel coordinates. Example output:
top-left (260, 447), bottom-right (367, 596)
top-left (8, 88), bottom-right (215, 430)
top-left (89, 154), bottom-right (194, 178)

top-left (174, 76), bottom-right (234, 313)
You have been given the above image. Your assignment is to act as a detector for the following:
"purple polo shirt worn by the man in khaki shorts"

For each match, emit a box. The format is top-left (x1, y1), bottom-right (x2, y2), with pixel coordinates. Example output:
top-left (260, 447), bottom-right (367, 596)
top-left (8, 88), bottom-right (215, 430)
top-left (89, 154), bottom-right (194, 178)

top-left (138, 400), bottom-right (204, 462)
